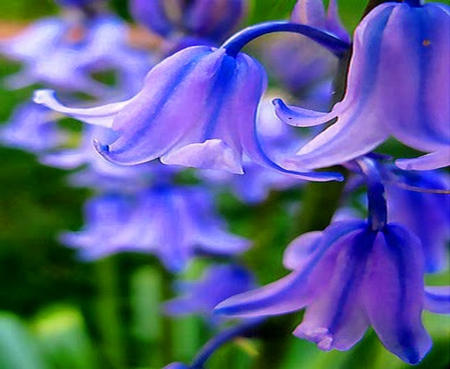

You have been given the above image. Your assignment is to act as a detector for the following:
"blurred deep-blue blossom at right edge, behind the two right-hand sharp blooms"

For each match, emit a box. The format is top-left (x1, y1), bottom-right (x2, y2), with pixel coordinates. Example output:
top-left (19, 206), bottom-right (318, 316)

top-left (386, 171), bottom-right (450, 272)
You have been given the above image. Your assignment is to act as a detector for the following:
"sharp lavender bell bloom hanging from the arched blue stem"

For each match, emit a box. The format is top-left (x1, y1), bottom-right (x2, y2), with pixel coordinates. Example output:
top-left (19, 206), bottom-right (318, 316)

top-left (35, 46), bottom-right (341, 181)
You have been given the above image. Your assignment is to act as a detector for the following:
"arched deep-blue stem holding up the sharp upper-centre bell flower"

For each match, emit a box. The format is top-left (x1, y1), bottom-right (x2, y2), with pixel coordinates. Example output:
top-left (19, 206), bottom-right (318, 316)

top-left (221, 21), bottom-right (350, 57)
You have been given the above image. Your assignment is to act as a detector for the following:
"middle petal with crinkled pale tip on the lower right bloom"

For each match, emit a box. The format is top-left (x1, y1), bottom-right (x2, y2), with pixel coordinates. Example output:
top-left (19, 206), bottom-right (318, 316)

top-left (294, 230), bottom-right (375, 350)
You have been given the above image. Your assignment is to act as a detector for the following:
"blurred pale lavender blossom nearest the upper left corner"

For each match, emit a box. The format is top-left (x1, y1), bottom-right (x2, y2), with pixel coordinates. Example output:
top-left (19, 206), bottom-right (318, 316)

top-left (0, 14), bottom-right (153, 98)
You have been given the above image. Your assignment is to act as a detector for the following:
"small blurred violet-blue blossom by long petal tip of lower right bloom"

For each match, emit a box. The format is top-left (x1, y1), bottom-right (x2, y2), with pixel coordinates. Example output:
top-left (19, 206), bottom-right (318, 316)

top-left (164, 264), bottom-right (256, 319)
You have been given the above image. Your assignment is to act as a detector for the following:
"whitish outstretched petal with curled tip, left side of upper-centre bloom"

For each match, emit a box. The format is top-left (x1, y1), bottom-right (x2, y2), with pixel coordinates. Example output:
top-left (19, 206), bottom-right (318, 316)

top-left (33, 90), bottom-right (130, 128)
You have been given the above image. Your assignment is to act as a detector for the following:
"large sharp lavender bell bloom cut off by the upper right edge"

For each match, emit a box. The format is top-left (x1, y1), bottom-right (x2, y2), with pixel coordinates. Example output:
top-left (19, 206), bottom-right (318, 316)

top-left (275, 2), bottom-right (450, 169)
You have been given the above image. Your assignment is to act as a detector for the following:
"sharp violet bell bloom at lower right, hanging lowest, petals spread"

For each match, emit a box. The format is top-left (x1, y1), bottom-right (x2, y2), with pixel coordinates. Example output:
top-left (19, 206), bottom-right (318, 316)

top-left (217, 220), bottom-right (438, 364)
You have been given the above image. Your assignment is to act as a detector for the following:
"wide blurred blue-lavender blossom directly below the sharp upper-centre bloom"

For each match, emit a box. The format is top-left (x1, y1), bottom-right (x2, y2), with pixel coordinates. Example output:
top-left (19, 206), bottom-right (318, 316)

top-left (61, 185), bottom-right (250, 272)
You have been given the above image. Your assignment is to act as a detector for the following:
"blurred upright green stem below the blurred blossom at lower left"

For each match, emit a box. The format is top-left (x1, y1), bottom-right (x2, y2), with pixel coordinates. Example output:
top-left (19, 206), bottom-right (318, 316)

top-left (94, 257), bottom-right (126, 369)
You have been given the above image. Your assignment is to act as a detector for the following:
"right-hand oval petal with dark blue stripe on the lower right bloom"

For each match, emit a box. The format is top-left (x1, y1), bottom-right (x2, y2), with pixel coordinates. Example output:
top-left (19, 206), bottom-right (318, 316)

top-left (362, 224), bottom-right (431, 364)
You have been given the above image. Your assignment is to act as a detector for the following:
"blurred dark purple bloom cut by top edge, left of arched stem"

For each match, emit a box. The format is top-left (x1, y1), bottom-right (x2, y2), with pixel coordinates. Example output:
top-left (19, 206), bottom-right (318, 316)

top-left (130, 0), bottom-right (247, 42)
